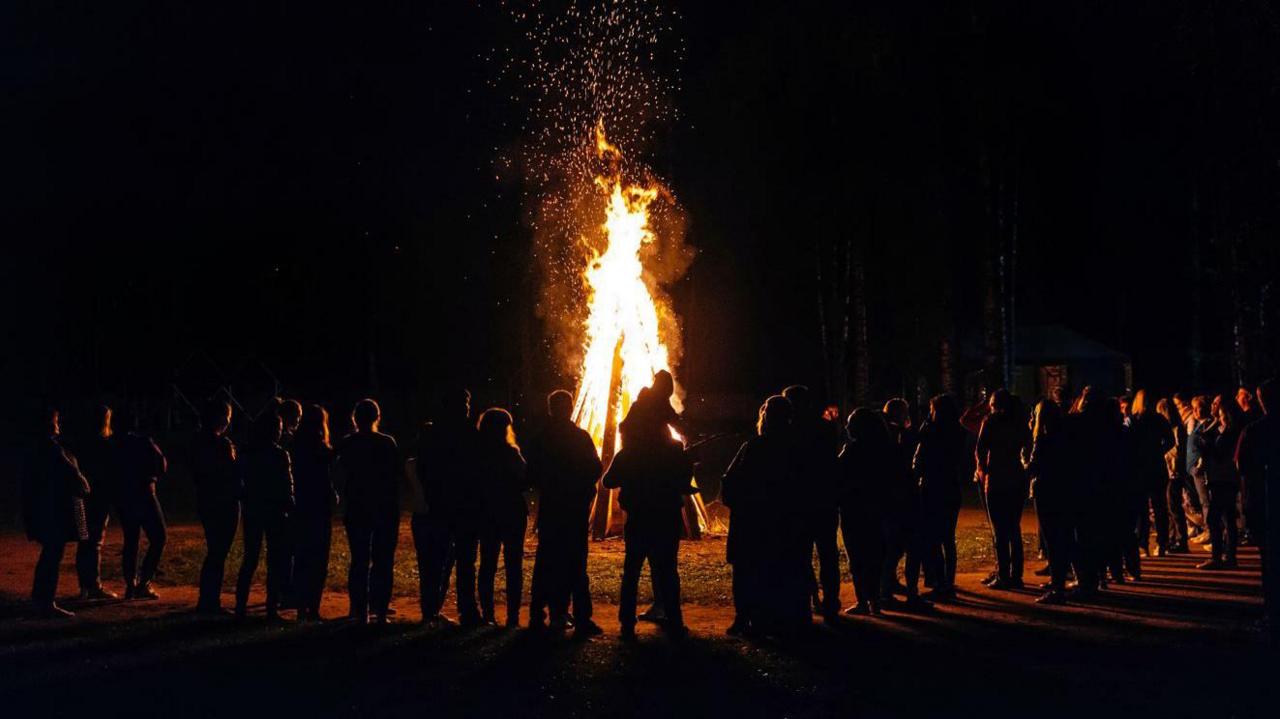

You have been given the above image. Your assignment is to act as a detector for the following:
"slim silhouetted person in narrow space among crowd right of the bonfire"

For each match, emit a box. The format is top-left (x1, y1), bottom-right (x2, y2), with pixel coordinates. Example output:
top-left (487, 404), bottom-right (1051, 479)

top-left (881, 398), bottom-right (919, 606)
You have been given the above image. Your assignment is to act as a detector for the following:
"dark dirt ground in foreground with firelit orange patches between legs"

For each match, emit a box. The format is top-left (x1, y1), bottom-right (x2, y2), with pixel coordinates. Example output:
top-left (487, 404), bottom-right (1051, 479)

top-left (0, 510), bottom-right (1280, 718)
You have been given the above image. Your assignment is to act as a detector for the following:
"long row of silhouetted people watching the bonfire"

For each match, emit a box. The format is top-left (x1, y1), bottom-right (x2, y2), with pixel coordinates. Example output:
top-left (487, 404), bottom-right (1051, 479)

top-left (12, 372), bottom-right (1280, 638)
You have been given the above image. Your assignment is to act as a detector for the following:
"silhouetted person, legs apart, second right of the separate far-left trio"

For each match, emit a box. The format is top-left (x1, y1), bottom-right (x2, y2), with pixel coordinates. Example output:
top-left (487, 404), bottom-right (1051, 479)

top-left (236, 413), bottom-right (294, 622)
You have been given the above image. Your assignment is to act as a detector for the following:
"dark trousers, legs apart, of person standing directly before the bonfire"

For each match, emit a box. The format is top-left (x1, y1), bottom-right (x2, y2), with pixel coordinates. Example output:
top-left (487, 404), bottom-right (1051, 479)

top-left (618, 514), bottom-right (685, 627)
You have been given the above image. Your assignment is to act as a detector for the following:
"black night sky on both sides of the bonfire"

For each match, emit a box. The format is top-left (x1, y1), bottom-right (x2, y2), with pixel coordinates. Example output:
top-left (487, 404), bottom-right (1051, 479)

top-left (10, 0), bottom-right (1280, 427)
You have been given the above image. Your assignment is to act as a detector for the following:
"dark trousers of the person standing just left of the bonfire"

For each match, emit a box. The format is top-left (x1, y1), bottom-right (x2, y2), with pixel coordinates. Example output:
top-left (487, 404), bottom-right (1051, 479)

top-left (529, 502), bottom-right (593, 623)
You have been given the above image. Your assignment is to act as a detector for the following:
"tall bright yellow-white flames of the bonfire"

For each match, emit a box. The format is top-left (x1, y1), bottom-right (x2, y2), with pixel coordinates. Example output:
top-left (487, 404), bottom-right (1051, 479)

top-left (573, 123), bottom-right (671, 449)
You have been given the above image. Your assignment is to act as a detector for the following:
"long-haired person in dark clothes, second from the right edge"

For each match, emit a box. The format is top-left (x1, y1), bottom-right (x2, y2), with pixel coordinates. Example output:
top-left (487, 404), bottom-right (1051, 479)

top-left (1198, 397), bottom-right (1244, 569)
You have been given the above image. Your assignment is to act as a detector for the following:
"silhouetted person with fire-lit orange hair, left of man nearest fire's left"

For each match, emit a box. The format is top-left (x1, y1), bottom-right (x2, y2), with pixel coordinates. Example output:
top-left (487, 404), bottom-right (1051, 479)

top-left (458, 407), bottom-right (529, 627)
